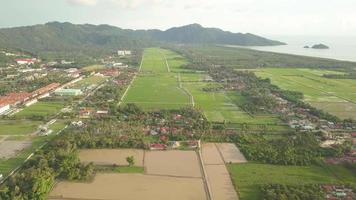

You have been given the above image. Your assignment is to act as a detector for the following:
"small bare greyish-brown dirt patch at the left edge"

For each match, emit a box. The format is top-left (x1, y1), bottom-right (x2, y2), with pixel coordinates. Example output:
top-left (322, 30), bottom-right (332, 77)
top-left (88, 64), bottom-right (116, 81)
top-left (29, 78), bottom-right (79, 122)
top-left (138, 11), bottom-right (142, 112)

top-left (0, 140), bottom-right (31, 159)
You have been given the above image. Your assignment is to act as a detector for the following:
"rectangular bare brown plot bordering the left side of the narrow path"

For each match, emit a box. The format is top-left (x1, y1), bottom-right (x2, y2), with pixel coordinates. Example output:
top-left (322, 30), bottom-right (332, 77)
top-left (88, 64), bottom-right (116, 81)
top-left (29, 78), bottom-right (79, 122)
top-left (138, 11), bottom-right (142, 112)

top-left (145, 151), bottom-right (202, 177)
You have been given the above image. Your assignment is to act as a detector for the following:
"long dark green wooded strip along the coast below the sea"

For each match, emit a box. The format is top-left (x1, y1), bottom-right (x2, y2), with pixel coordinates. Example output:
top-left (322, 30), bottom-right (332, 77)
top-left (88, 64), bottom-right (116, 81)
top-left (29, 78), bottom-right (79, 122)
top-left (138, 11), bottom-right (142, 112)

top-left (170, 45), bottom-right (355, 71)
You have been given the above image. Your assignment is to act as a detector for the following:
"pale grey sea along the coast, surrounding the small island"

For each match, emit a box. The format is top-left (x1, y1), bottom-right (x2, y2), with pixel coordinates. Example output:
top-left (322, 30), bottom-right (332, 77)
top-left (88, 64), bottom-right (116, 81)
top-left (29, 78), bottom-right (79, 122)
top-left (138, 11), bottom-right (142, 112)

top-left (243, 36), bottom-right (356, 62)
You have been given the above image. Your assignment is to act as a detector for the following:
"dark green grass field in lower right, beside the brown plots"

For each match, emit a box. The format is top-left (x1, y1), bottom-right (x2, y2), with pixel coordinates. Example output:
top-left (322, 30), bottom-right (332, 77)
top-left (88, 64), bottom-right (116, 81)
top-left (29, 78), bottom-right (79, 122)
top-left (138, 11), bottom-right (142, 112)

top-left (227, 163), bottom-right (356, 200)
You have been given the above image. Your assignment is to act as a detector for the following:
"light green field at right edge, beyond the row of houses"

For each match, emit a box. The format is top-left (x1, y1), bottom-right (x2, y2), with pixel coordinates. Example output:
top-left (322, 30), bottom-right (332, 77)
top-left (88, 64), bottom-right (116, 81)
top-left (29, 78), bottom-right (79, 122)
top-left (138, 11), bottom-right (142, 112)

top-left (256, 68), bottom-right (356, 119)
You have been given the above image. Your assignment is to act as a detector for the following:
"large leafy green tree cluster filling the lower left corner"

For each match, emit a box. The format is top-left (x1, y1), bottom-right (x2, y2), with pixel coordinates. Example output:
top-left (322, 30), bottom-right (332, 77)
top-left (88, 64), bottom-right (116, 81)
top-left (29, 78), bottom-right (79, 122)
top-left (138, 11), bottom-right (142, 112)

top-left (0, 137), bottom-right (94, 200)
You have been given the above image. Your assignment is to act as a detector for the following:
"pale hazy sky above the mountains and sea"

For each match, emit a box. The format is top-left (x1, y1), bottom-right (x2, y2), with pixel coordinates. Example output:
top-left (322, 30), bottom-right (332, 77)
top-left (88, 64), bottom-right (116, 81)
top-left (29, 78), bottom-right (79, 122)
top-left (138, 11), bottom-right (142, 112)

top-left (0, 0), bottom-right (356, 36)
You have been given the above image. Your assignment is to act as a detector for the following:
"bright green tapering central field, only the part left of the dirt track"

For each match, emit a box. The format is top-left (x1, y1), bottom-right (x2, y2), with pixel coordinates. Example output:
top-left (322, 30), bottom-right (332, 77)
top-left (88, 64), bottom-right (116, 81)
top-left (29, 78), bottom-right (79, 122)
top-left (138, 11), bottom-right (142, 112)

top-left (124, 49), bottom-right (191, 109)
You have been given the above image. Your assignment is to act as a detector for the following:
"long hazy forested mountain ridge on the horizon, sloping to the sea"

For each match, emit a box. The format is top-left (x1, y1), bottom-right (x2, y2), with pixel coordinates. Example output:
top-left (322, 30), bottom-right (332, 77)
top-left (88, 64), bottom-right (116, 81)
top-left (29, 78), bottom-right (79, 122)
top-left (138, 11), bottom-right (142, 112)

top-left (0, 22), bottom-right (284, 53)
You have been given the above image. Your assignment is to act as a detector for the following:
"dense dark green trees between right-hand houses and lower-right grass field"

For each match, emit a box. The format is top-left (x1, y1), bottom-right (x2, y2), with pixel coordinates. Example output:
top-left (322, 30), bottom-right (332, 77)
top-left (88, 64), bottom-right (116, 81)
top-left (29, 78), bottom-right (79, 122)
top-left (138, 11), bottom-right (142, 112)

top-left (237, 134), bottom-right (322, 165)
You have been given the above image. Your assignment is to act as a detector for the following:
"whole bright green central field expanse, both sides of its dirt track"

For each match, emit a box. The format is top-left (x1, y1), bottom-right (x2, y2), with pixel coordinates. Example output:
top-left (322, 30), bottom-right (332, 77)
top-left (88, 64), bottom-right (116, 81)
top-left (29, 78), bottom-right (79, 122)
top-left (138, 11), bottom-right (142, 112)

top-left (124, 49), bottom-right (286, 126)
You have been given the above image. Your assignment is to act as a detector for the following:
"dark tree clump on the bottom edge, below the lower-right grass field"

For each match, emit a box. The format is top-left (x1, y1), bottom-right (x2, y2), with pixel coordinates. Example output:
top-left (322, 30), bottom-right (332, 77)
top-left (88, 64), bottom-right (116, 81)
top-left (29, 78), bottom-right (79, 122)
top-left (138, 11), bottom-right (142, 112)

top-left (261, 184), bottom-right (326, 200)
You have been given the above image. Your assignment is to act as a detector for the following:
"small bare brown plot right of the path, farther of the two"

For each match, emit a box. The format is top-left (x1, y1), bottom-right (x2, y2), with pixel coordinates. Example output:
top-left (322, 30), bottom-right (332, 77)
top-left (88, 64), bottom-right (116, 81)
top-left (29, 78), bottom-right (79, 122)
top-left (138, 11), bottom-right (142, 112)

top-left (216, 143), bottom-right (247, 163)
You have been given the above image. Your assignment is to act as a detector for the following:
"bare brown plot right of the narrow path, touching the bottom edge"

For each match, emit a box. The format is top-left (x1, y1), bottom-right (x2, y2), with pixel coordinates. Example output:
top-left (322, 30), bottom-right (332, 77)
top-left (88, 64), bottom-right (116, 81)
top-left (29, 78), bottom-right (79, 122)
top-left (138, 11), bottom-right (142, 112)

top-left (205, 165), bottom-right (238, 200)
